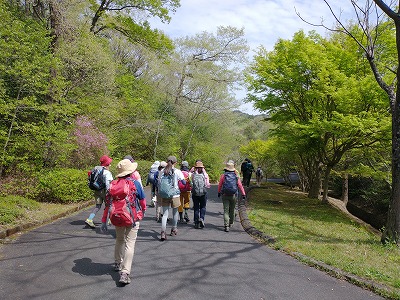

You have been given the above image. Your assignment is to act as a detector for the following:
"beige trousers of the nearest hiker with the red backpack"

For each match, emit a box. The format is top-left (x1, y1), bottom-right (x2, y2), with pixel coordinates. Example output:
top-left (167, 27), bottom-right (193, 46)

top-left (114, 222), bottom-right (139, 274)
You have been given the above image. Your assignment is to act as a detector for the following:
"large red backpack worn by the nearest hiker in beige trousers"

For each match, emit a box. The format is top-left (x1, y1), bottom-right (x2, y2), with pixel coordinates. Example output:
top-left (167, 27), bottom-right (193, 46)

top-left (108, 178), bottom-right (143, 227)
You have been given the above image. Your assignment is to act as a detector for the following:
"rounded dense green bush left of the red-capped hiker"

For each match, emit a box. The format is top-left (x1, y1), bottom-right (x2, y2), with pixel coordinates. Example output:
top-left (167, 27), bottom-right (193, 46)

top-left (35, 169), bottom-right (93, 203)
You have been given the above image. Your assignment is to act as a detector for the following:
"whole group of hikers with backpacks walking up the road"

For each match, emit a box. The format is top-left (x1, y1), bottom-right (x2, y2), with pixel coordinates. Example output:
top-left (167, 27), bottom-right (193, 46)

top-left (85, 155), bottom-right (258, 284)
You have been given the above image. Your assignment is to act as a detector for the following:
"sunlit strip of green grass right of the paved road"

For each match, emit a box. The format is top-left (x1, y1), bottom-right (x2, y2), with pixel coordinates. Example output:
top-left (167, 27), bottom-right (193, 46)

top-left (248, 185), bottom-right (400, 299)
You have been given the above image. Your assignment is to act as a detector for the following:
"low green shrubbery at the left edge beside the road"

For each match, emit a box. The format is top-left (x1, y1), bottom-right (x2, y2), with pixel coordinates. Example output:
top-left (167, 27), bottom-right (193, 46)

top-left (0, 195), bottom-right (39, 224)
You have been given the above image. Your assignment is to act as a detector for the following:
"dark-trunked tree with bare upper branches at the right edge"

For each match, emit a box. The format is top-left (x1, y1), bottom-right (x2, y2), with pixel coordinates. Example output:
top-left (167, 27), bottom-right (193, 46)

top-left (298, 0), bottom-right (400, 245)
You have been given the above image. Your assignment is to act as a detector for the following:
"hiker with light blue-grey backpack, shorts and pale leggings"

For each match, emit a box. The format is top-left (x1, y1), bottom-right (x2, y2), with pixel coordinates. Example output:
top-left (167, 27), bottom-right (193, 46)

top-left (158, 156), bottom-right (186, 241)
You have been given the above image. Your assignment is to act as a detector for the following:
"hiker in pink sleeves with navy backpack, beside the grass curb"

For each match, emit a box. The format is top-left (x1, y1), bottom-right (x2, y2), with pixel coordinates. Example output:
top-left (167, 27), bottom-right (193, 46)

top-left (218, 160), bottom-right (246, 232)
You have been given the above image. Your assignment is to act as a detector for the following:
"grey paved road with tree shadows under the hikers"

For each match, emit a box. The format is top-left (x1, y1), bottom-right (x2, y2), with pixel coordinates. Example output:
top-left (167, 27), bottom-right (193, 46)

top-left (0, 186), bottom-right (382, 300)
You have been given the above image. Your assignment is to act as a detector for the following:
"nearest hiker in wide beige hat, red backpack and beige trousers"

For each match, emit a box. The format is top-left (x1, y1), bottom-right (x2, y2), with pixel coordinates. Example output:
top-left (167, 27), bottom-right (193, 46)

top-left (101, 159), bottom-right (146, 284)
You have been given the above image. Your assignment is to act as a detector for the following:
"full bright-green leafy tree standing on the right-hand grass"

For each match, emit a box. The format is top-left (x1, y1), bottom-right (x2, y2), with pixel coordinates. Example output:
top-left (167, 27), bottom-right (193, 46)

top-left (248, 32), bottom-right (387, 202)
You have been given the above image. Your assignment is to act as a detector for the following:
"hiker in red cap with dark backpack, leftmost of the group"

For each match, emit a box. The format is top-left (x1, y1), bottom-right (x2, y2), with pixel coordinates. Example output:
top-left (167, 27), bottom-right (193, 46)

top-left (85, 155), bottom-right (113, 228)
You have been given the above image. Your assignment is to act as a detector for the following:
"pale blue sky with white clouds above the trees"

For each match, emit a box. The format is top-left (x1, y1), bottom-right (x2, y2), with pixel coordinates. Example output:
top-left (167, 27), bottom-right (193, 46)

top-left (151, 0), bottom-right (352, 114)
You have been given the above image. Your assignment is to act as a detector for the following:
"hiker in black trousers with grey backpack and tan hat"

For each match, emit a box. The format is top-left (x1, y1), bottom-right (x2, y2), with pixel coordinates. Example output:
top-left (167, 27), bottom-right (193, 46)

top-left (190, 160), bottom-right (210, 229)
